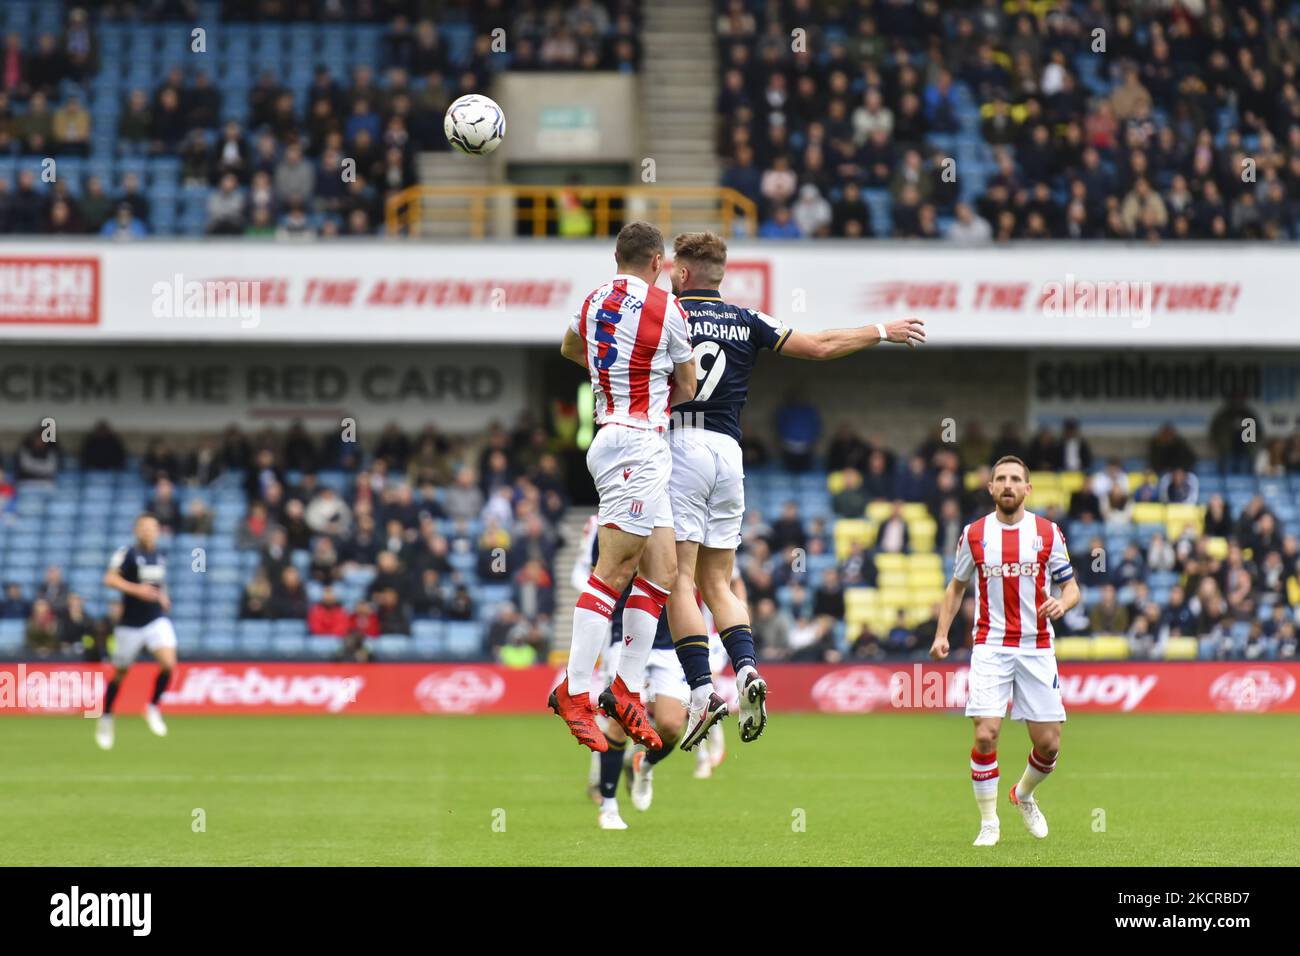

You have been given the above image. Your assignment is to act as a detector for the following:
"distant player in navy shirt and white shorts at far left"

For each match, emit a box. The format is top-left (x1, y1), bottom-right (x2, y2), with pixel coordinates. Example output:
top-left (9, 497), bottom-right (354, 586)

top-left (95, 514), bottom-right (176, 750)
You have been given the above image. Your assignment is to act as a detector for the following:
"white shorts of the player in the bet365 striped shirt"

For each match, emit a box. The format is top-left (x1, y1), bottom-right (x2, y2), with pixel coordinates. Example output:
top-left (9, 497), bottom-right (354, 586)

top-left (966, 644), bottom-right (1065, 723)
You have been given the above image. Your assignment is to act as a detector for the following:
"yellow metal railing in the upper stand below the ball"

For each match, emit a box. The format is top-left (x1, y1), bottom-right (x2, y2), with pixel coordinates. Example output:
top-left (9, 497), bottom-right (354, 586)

top-left (385, 186), bottom-right (758, 239)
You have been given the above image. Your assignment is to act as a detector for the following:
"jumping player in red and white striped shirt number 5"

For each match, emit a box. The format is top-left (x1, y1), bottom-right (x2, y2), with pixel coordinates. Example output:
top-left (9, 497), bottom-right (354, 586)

top-left (550, 221), bottom-right (696, 753)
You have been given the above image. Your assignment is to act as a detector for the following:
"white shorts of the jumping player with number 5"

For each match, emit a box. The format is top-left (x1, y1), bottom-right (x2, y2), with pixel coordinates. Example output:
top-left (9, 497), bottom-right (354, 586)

top-left (586, 425), bottom-right (672, 537)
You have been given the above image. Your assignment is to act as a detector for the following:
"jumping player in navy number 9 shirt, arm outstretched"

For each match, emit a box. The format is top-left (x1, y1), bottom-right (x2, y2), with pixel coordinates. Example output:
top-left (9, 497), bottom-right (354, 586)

top-left (668, 233), bottom-right (926, 750)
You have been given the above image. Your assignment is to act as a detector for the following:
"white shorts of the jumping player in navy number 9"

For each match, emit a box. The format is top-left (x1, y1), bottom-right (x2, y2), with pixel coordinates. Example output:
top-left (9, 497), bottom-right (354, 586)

top-left (668, 428), bottom-right (745, 550)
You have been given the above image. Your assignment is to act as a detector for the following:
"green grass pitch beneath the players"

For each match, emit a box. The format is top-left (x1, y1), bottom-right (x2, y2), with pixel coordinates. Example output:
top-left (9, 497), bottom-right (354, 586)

top-left (0, 713), bottom-right (1300, 866)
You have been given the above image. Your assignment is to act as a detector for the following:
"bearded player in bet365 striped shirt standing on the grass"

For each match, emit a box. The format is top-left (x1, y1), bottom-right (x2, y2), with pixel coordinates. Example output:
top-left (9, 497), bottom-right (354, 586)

top-left (930, 455), bottom-right (1079, 847)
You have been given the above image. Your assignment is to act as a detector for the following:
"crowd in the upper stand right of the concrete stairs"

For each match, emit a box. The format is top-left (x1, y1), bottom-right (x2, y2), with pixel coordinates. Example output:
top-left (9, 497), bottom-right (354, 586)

top-left (716, 0), bottom-right (1300, 242)
